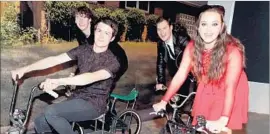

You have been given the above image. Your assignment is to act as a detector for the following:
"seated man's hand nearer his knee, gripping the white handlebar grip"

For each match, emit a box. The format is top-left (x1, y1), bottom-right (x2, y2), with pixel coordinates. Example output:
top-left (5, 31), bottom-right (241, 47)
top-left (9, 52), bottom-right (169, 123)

top-left (40, 79), bottom-right (60, 92)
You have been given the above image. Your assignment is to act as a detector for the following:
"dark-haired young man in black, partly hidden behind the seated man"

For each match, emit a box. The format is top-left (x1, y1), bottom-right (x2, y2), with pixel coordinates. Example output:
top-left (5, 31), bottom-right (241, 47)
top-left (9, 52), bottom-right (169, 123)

top-left (75, 6), bottom-right (128, 81)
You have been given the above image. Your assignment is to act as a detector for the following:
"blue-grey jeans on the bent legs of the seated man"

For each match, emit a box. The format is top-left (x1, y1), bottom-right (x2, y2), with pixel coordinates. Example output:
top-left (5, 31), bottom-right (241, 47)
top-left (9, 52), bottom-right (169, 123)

top-left (44, 99), bottom-right (99, 134)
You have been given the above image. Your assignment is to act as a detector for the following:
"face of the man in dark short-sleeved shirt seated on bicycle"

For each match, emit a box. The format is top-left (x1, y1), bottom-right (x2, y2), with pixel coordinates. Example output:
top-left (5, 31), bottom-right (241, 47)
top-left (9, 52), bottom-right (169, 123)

top-left (94, 22), bottom-right (114, 47)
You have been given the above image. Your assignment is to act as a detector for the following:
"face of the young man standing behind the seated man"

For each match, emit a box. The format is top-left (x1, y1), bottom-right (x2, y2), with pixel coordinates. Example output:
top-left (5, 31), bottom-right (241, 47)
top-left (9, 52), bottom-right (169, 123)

top-left (75, 13), bottom-right (91, 31)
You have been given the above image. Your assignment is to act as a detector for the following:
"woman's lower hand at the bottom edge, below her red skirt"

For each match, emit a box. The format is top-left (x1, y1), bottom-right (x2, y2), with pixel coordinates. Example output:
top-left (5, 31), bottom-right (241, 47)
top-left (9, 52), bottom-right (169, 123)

top-left (206, 116), bottom-right (229, 133)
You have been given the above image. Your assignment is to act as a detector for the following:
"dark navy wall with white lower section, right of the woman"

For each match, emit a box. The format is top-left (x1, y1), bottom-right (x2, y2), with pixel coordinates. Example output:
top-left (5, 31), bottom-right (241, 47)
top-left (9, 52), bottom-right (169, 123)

top-left (231, 1), bottom-right (270, 114)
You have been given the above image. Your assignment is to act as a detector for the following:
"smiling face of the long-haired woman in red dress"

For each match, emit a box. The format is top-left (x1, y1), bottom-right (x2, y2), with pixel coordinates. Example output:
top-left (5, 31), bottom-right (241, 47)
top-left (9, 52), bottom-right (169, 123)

top-left (198, 11), bottom-right (223, 45)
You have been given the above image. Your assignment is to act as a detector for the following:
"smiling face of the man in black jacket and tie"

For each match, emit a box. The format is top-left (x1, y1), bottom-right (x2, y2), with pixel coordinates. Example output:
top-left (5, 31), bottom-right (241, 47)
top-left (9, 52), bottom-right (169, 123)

top-left (157, 20), bottom-right (173, 41)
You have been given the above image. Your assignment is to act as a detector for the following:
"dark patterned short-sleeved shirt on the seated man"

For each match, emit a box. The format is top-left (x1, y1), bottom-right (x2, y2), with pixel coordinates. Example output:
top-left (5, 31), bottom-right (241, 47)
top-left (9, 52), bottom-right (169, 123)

top-left (67, 45), bottom-right (120, 114)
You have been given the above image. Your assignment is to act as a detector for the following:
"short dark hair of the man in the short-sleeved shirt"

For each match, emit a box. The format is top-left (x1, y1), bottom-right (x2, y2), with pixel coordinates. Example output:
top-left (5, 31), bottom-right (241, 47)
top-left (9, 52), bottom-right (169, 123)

top-left (95, 17), bottom-right (118, 37)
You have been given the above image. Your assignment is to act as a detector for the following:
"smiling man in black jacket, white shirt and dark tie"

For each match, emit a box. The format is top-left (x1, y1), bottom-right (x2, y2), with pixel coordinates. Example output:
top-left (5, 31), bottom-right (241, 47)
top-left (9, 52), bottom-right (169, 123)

top-left (156, 17), bottom-right (193, 106)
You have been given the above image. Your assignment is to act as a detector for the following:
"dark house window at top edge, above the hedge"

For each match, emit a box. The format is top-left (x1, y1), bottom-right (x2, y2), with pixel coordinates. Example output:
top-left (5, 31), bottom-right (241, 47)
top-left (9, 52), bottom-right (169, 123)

top-left (125, 1), bottom-right (150, 13)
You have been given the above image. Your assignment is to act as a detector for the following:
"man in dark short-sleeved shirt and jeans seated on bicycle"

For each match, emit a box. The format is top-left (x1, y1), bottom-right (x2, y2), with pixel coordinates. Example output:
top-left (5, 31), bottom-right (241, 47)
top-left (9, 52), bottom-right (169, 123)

top-left (12, 18), bottom-right (120, 134)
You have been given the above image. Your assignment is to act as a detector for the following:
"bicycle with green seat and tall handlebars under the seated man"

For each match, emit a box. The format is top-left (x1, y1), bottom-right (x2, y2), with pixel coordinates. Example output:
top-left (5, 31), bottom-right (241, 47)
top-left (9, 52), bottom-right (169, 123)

top-left (6, 76), bottom-right (141, 134)
